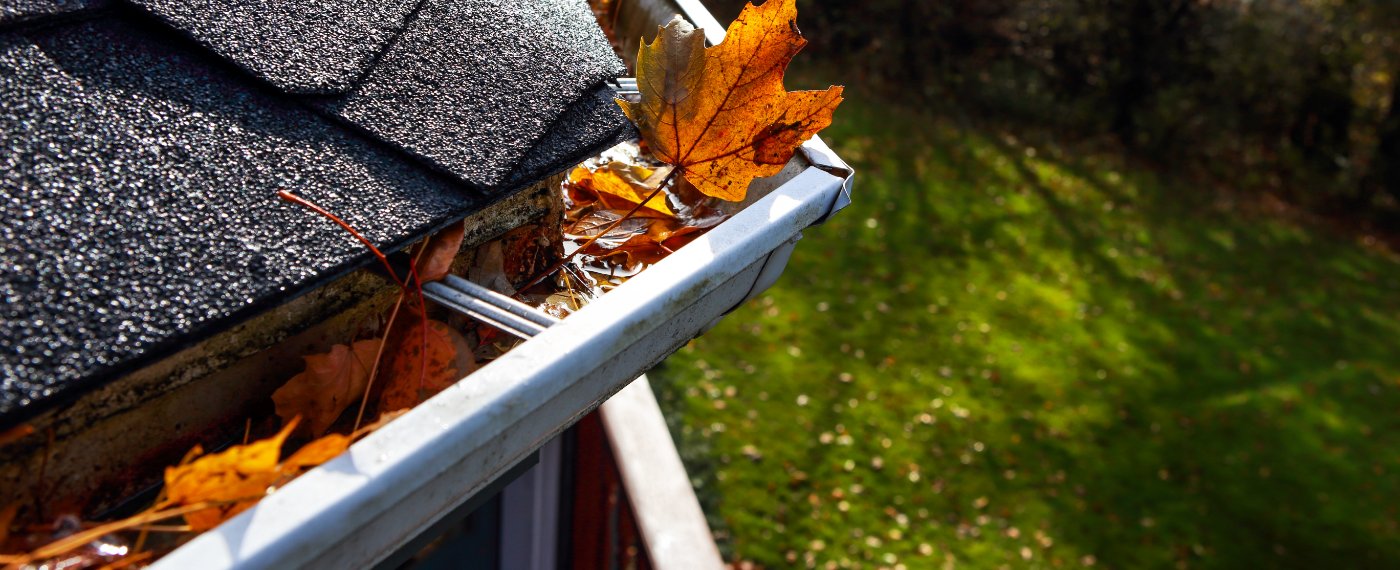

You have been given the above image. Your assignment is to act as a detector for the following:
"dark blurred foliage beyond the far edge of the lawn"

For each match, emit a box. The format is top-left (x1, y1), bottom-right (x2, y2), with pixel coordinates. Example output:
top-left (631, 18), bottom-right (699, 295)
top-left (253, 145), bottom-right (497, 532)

top-left (707, 0), bottom-right (1400, 223)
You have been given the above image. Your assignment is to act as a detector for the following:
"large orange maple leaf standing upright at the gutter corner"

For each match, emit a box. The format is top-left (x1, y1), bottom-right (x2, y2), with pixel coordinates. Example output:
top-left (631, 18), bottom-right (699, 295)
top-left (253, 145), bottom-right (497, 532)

top-left (617, 0), bottom-right (841, 202)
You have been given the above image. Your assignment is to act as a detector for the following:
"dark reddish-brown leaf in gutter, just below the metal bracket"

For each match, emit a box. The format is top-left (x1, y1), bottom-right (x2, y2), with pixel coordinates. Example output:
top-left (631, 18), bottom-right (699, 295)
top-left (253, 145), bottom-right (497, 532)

top-left (379, 319), bottom-right (476, 410)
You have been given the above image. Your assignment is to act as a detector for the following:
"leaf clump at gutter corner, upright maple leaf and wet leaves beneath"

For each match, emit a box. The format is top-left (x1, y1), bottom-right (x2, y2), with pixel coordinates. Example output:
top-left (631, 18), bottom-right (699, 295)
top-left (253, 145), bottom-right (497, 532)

top-left (543, 0), bottom-right (843, 303)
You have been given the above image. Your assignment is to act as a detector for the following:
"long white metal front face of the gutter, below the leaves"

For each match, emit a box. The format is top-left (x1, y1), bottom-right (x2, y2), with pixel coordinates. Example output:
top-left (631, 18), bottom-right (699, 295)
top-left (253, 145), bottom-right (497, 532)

top-left (153, 5), bottom-right (851, 569)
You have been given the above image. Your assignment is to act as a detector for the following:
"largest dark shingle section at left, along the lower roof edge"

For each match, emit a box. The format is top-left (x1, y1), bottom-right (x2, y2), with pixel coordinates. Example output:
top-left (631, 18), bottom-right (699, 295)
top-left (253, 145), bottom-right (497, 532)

top-left (0, 20), bottom-right (484, 424)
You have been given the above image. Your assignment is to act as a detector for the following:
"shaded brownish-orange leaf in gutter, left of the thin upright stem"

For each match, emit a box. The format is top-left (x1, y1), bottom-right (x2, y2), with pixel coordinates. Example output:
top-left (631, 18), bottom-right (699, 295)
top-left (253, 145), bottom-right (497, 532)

top-left (272, 339), bottom-right (382, 436)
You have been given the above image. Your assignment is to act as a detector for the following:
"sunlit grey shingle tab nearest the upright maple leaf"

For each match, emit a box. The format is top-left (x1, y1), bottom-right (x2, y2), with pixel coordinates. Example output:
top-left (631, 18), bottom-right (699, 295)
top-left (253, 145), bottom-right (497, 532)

top-left (319, 0), bottom-right (626, 190)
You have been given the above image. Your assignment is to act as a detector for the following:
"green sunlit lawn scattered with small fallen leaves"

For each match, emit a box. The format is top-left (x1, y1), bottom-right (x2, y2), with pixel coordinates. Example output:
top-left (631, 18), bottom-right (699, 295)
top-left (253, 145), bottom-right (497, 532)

top-left (652, 91), bottom-right (1400, 569)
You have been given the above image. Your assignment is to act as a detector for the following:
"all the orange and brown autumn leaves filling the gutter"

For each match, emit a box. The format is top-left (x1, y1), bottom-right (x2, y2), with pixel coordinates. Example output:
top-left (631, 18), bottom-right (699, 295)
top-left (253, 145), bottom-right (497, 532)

top-left (0, 0), bottom-right (841, 569)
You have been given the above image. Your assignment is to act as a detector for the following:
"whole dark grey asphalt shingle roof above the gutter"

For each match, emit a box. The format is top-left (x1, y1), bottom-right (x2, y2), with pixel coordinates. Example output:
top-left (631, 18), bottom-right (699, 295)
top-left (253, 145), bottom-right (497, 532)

top-left (0, 0), bottom-right (630, 429)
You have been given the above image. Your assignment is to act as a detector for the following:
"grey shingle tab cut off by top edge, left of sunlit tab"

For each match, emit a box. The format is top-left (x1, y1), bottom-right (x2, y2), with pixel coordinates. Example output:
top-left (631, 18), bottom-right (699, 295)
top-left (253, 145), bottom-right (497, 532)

top-left (133, 0), bottom-right (419, 94)
